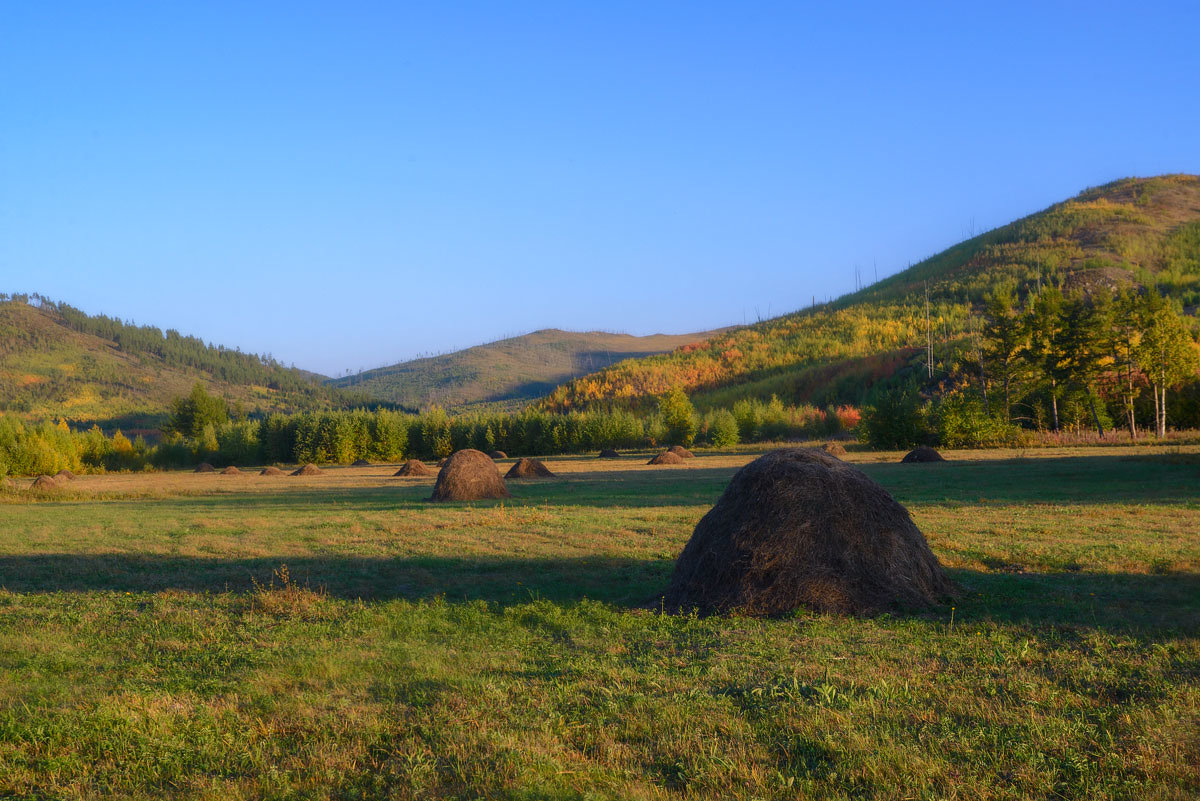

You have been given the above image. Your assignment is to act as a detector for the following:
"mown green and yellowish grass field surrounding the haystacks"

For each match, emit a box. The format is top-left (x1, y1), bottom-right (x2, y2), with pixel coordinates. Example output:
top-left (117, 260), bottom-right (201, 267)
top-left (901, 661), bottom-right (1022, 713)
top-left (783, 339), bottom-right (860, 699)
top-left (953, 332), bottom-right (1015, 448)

top-left (0, 448), bottom-right (1200, 800)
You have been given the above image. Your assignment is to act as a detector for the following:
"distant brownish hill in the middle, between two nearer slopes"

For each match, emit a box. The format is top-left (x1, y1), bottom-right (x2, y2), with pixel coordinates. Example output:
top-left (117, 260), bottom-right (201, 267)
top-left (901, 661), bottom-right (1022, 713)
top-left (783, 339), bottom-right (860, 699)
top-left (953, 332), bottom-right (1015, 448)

top-left (330, 329), bottom-right (718, 409)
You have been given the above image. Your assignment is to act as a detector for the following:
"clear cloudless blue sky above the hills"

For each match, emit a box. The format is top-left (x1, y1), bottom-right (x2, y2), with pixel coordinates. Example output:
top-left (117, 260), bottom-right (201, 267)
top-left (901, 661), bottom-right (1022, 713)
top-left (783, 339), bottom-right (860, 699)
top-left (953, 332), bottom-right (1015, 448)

top-left (0, 0), bottom-right (1200, 374)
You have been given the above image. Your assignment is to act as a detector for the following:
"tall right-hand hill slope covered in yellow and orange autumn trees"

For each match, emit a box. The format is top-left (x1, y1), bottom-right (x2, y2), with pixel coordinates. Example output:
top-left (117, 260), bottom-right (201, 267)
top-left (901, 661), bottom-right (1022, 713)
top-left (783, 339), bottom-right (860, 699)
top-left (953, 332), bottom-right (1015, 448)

top-left (541, 175), bottom-right (1200, 411)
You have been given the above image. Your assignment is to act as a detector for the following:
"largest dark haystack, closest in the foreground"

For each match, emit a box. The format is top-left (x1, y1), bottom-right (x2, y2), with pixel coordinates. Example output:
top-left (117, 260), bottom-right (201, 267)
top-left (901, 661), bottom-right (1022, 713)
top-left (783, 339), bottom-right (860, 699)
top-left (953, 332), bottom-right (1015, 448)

top-left (664, 448), bottom-right (954, 615)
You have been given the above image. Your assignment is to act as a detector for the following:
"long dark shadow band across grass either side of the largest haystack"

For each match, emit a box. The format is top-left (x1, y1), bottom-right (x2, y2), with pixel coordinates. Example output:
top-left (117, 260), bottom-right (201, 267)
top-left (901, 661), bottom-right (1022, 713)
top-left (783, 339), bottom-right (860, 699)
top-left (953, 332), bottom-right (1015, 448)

top-left (0, 554), bottom-right (1200, 633)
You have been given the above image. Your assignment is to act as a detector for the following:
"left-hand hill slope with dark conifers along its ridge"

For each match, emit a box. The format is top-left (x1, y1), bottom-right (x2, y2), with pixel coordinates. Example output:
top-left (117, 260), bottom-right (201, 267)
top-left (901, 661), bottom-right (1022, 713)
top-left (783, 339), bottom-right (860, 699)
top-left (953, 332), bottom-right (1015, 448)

top-left (0, 295), bottom-right (364, 428)
